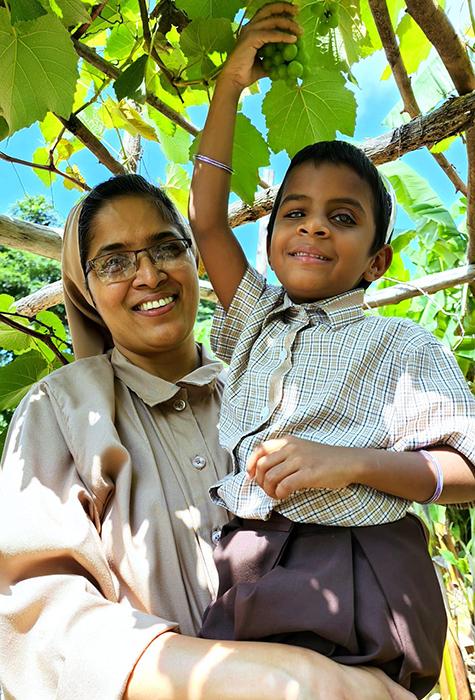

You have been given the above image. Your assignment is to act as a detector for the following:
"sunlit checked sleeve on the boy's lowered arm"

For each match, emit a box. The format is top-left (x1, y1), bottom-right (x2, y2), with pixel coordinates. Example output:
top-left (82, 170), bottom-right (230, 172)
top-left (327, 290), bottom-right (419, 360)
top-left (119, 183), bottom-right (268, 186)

top-left (387, 342), bottom-right (475, 508)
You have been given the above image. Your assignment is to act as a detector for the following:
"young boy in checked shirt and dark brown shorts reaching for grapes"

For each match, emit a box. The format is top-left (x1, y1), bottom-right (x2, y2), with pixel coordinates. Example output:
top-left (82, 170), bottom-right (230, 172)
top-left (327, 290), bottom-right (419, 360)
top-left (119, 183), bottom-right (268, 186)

top-left (190, 3), bottom-right (475, 697)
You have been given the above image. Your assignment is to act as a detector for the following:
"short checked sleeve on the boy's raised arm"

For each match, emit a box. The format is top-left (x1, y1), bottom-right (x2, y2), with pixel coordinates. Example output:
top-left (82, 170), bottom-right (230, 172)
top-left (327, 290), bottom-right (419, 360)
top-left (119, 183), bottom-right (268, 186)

top-left (211, 266), bottom-right (269, 364)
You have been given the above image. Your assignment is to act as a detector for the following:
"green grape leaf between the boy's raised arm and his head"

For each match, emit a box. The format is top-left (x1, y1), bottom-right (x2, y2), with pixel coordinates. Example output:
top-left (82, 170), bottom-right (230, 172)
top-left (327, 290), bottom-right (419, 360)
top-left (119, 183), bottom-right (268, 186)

top-left (231, 114), bottom-right (270, 204)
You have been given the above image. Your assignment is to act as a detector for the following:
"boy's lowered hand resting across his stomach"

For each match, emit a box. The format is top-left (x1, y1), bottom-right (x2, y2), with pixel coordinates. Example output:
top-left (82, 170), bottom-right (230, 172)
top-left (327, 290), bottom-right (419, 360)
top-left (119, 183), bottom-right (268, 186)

top-left (246, 435), bottom-right (356, 499)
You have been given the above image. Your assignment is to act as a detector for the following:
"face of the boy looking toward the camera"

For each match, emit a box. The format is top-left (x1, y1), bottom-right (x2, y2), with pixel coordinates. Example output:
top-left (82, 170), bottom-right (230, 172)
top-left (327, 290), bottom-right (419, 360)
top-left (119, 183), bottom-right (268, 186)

top-left (268, 162), bottom-right (392, 303)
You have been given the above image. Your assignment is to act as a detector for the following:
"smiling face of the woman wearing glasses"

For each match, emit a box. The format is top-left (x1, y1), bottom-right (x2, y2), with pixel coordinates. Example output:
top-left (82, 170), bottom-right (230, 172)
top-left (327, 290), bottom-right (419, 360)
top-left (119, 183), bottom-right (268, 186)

top-left (87, 195), bottom-right (199, 374)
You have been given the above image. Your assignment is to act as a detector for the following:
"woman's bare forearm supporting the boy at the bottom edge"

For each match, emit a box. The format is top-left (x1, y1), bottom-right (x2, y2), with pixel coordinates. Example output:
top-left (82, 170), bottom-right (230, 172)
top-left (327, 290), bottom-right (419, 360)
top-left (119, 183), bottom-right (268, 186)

top-left (124, 632), bottom-right (414, 700)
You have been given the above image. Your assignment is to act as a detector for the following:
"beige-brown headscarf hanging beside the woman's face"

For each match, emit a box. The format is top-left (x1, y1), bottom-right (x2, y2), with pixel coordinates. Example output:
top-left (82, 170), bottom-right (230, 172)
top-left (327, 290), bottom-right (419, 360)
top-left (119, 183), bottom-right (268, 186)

top-left (61, 202), bottom-right (113, 360)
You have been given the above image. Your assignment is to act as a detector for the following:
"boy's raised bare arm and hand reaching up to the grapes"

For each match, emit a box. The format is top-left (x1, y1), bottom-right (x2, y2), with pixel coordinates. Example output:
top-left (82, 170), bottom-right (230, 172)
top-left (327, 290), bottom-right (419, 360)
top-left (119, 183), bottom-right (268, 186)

top-left (189, 2), bottom-right (300, 310)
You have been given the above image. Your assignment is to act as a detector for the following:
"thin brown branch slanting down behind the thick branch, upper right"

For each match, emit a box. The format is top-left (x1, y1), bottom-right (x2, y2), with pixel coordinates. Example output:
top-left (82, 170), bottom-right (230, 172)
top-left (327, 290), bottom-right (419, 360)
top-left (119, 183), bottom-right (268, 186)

top-left (369, 0), bottom-right (467, 196)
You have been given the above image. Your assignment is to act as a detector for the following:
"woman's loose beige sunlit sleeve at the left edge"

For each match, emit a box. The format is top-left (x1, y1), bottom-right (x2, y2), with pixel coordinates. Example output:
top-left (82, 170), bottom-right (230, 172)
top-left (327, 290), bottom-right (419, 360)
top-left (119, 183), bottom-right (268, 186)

top-left (0, 384), bottom-right (176, 700)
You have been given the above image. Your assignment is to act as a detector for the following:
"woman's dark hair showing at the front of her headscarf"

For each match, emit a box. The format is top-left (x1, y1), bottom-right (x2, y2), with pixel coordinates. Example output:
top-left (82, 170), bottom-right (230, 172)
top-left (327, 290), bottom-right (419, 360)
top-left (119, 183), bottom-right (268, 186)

top-left (78, 173), bottom-right (191, 271)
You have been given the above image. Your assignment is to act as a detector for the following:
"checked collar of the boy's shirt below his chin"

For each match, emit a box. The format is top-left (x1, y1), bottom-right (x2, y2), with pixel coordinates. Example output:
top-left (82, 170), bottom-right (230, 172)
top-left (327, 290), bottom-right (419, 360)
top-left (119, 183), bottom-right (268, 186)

top-left (275, 289), bottom-right (364, 328)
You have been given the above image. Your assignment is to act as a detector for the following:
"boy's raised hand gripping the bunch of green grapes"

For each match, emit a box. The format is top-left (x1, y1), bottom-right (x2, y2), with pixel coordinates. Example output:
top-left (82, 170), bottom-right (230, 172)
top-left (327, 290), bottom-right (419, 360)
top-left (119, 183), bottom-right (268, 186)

top-left (218, 2), bottom-right (302, 91)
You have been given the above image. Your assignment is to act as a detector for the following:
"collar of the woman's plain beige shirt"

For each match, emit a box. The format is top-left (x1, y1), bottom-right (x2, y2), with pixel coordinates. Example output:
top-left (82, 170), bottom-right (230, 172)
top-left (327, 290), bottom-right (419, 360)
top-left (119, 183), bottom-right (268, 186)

top-left (110, 345), bottom-right (223, 406)
